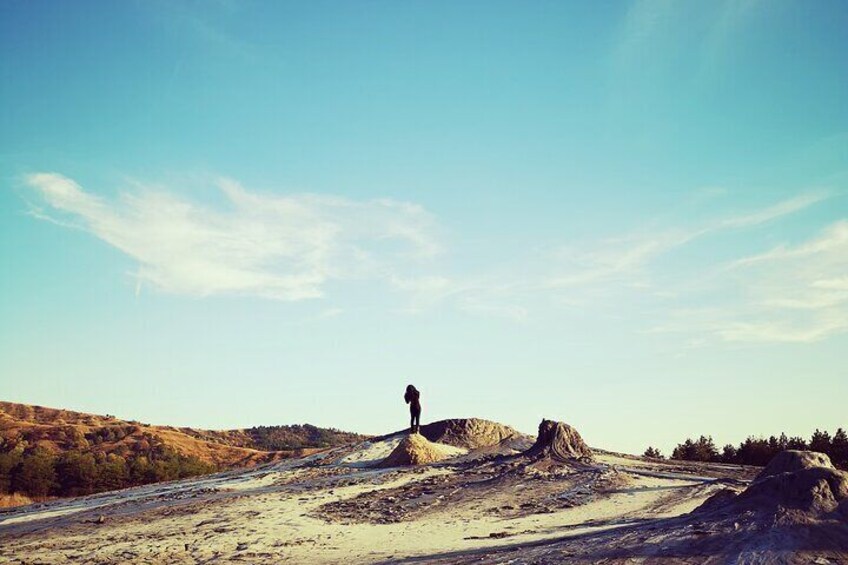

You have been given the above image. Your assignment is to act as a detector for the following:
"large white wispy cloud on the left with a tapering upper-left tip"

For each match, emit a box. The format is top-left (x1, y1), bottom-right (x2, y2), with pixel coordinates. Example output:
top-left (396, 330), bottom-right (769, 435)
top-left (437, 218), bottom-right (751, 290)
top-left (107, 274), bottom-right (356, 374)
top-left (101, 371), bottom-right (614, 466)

top-left (26, 173), bottom-right (440, 300)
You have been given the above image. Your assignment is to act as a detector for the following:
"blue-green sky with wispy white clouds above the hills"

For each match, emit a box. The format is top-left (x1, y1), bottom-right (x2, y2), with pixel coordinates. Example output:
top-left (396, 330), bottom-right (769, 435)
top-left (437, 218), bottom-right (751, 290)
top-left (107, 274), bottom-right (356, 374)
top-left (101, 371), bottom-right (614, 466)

top-left (0, 0), bottom-right (848, 453)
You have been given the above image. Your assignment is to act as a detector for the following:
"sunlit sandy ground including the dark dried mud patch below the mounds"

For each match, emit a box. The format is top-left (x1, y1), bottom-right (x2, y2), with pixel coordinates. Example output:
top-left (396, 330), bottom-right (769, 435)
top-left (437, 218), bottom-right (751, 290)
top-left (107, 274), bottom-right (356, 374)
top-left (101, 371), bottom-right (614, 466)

top-left (0, 436), bottom-right (838, 564)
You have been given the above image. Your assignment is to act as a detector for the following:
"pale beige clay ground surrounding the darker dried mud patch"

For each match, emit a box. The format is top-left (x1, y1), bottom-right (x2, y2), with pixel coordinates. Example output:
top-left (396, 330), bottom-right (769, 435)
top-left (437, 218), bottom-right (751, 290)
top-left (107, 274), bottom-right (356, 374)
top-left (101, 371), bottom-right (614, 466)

top-left (0, 437), bottom-right (736, 563)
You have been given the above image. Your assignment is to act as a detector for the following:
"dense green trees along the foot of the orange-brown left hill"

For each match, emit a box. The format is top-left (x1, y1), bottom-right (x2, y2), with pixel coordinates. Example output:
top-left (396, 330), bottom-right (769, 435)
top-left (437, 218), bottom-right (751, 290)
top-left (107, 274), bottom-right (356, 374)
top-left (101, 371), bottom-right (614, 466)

top-left (0, 444), bottom-right (217, 499)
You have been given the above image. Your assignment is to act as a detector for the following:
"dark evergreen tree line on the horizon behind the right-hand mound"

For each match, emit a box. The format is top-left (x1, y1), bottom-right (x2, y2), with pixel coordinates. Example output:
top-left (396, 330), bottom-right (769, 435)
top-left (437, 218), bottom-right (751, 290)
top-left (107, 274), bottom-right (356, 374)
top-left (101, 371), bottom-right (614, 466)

top-left (644, 428), bottom-right (848, 469)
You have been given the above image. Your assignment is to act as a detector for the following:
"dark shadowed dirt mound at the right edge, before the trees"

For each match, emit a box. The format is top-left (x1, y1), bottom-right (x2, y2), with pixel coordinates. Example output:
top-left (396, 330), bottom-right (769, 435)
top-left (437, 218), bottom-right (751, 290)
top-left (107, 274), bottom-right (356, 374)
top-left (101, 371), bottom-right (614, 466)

top-left (702, 451), bottom-right (848, 523)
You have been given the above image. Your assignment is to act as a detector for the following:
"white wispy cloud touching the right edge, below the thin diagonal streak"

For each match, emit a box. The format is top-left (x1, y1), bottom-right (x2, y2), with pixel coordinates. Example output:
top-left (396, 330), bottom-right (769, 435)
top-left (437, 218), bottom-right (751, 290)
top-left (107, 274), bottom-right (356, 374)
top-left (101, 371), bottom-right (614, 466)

top-left (651, 220), bottom-right (848, 344)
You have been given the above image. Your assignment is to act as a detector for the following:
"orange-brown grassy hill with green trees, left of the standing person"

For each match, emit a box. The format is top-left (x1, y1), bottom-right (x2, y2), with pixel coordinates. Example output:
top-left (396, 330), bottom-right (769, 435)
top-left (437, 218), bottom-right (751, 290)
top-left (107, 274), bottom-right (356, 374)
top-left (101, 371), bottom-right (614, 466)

top-left (0, 402), bottom-right (363, 504)
